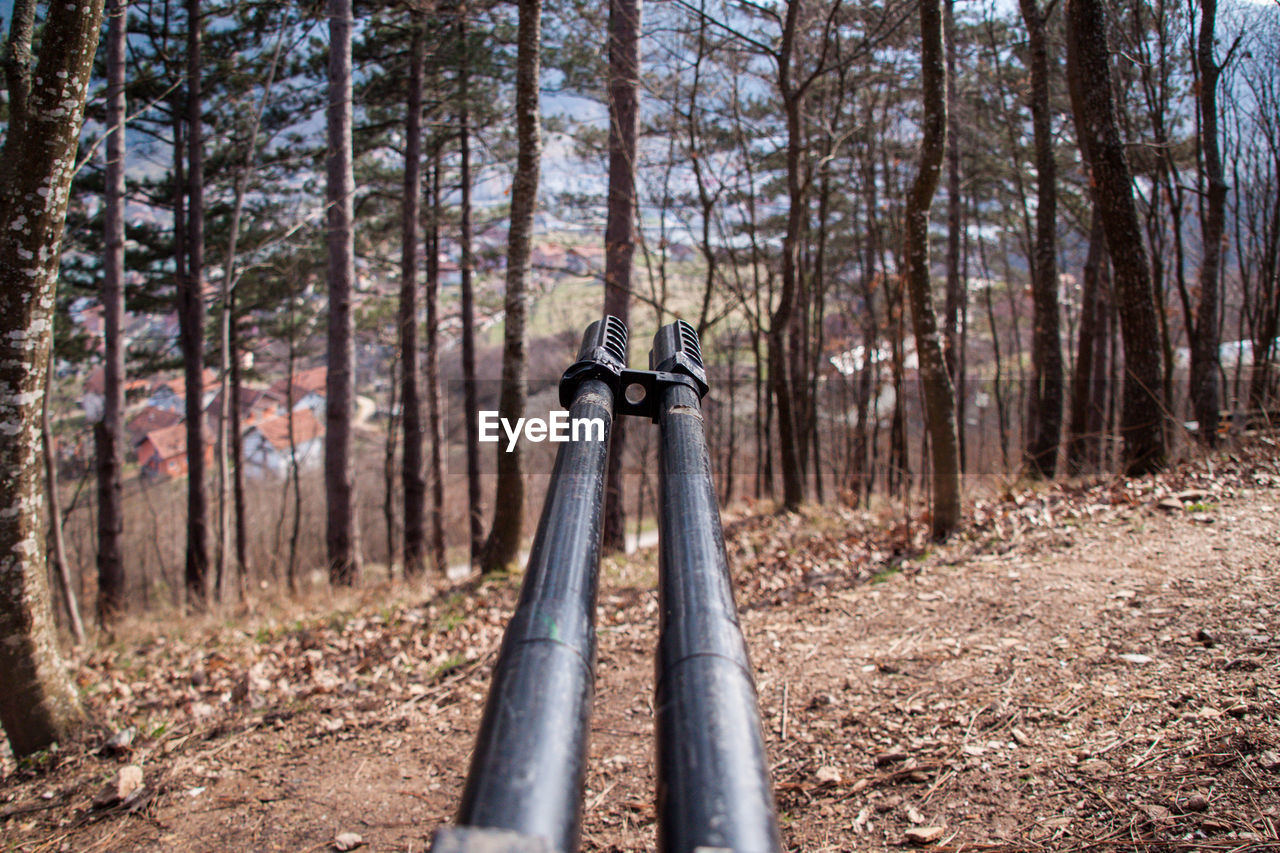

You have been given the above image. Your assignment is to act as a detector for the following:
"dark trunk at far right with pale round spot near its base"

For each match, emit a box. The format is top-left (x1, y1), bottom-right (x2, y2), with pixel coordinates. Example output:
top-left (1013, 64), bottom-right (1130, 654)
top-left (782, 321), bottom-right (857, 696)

top-left (1190, 0), bottom-right (1226, 447)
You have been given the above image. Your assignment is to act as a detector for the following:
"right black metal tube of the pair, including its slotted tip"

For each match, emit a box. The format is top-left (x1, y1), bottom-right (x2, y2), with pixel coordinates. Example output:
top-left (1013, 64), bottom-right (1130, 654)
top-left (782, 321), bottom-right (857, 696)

top-left (650, 323), bottom-right (782, 853)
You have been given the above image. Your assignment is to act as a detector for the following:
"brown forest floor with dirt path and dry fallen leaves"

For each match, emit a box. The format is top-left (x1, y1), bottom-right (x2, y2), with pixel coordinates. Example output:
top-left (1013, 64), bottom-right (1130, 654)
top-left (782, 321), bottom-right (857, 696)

top-left (0, 439), bottom-right (1280, 852)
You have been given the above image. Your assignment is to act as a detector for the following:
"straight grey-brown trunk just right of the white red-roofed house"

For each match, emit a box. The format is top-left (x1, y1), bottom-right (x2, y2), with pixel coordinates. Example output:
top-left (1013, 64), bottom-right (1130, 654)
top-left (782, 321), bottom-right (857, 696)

top-left (324, 0), bottom-right (360, 587)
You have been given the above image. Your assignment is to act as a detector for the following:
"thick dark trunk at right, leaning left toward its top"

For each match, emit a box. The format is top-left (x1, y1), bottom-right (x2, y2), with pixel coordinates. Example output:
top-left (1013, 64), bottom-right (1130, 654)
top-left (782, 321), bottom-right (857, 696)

top-left (1066, 0), bottom-right (1165, 476)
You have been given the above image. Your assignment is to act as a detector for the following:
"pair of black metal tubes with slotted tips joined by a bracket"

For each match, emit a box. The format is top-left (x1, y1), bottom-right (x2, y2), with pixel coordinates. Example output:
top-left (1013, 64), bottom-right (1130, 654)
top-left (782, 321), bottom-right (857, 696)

top-left (431, 316), bottom-right (781, 853)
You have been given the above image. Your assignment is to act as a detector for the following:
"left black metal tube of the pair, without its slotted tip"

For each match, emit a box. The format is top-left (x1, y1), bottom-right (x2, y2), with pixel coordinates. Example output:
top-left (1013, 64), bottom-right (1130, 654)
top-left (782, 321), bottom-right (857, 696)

top-left (458, 373), bottom-right (625, 853)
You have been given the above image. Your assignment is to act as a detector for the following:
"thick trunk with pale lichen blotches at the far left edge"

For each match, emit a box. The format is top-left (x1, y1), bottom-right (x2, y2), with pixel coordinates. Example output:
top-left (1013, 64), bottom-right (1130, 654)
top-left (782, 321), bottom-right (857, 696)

top-left (0, 0), bottom-right (102, 757)
